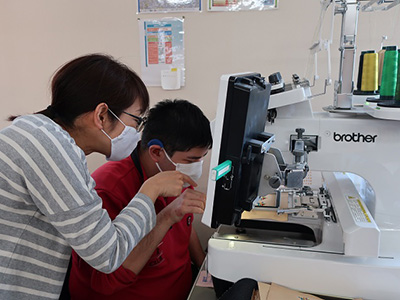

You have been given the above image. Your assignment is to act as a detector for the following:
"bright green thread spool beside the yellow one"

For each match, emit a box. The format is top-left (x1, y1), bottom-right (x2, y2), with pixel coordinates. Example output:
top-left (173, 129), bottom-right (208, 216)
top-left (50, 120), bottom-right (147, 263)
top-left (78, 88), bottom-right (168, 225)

top-left (380, 49), bottom-right (399, 100)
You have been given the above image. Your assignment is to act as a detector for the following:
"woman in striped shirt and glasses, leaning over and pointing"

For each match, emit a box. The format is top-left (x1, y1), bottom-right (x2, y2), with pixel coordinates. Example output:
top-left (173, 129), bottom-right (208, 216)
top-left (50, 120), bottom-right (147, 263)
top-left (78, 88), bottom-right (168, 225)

top-left (0, 54), bottom-right (199, 300)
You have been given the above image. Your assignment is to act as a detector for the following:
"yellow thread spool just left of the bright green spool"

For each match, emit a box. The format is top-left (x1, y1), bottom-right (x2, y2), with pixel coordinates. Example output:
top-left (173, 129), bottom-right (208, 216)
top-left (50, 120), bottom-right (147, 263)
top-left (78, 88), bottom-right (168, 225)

top-left (361, 53), bottom-right (378, 92)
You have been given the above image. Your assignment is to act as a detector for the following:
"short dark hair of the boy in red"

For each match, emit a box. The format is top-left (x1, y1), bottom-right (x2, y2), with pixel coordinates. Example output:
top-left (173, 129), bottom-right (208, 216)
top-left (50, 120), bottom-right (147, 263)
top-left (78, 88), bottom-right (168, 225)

top-left (141, 99), bottom-right (212, 156)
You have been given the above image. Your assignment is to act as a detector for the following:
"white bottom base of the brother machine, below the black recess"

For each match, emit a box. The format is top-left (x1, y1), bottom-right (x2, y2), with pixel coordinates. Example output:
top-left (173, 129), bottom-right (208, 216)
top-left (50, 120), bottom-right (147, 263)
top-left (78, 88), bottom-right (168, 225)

top-left (208, 238), bottom-right (400, 300)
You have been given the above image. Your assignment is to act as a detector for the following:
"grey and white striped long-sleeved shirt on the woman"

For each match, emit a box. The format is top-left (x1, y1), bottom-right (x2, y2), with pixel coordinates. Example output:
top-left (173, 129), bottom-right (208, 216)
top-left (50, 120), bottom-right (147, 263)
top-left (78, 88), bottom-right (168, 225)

top-left (0, 114), bottom-right (155, 300)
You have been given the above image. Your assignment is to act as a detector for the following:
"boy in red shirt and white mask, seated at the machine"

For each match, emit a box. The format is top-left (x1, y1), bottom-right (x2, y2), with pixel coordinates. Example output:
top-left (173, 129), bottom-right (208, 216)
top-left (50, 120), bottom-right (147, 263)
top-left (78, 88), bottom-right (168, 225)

top-left (70, 100), bottom-right (212, 300)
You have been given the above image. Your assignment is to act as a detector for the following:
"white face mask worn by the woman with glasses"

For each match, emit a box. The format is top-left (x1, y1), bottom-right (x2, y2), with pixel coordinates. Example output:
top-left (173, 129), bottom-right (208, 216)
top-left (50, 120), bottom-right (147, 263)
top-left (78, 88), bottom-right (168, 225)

top-left (101, 109), bottom-right (140, 161)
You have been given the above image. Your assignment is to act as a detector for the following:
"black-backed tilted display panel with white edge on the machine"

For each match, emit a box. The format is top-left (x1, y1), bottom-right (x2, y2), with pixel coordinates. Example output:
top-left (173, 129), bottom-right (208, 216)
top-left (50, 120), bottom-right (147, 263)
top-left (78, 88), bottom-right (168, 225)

top-left (203, 73), bottom-right (271, 228)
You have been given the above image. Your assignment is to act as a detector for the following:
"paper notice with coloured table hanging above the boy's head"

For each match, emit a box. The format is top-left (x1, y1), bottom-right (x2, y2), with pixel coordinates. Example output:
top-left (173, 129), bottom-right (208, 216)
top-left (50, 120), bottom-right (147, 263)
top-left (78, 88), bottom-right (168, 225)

top-left (139, 18), bottom-right (185, 86)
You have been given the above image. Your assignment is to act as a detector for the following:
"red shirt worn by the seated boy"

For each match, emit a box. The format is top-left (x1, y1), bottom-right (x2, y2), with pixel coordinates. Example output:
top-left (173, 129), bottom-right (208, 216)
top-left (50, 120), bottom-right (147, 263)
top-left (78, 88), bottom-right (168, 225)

top-left (69, 157), bottom-right (193, 300)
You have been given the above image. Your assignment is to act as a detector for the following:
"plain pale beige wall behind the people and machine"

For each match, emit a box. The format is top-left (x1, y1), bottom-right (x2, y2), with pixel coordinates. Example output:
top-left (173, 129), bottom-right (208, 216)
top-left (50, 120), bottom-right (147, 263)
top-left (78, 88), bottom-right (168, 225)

top-left (0, 0), bottom-right (400, 248)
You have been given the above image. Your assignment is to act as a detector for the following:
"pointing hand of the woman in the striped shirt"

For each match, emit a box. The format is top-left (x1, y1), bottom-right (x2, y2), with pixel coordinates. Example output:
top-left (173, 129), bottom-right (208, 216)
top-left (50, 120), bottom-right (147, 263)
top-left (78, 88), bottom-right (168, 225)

top-left (139, 171), bottom-right (197, 202)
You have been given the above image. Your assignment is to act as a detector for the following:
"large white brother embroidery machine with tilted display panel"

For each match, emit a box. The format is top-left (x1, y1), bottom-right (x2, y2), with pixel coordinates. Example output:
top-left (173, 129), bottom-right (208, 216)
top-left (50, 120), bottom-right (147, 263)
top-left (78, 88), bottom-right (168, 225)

top-left (202, 1), bottom-right (400, 300)
